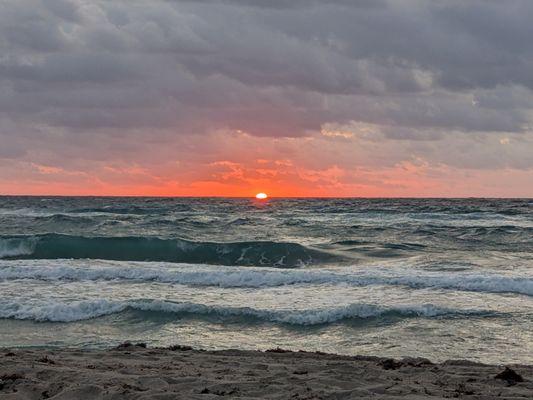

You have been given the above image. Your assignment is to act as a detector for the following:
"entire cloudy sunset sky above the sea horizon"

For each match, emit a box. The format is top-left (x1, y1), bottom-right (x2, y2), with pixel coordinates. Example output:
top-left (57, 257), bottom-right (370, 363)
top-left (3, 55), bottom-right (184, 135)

top-left (0, 0), bottom-right (533, 197)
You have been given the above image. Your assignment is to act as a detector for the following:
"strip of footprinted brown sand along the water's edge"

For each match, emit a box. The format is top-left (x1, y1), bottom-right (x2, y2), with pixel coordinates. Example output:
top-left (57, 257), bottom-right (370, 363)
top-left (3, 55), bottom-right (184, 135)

top-left (0, 345), bottom-right (533, 400)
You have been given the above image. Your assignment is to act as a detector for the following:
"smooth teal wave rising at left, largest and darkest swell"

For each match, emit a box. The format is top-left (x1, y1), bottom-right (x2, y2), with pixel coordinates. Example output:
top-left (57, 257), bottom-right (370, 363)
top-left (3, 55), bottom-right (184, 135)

top-left (0, 233), bottom-right (340, 268)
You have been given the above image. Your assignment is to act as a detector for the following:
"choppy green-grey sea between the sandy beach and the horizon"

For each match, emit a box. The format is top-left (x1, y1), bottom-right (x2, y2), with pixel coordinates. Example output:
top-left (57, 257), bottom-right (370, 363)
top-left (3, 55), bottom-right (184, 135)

top-left (0, 197), bottom-right (533, 363)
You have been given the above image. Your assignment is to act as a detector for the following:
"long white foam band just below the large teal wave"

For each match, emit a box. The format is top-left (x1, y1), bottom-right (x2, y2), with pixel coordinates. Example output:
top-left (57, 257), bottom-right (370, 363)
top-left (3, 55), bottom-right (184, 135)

top-left (0, 260), bottom-right (533, 296)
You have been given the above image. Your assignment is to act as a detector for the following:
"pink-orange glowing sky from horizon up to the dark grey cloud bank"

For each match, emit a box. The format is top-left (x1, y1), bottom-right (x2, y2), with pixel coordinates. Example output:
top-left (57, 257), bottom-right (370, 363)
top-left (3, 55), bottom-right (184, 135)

top-left (0, 132), bottom-right (531, 197)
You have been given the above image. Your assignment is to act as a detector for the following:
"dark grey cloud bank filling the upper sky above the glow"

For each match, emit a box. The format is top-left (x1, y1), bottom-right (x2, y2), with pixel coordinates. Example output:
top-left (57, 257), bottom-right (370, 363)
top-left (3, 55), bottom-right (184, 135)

top-left (0, 0), bottom-right (533, 175)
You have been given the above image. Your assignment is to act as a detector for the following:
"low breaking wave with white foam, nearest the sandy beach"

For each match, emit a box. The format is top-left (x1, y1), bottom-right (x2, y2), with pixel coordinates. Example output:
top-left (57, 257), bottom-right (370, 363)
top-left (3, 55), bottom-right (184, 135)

top-left (0, 299), bottom-right (490, 326)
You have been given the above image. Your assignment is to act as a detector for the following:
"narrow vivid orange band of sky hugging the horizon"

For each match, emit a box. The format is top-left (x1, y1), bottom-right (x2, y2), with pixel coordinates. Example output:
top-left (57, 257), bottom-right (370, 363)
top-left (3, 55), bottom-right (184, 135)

top-left (0, 139), bottom-right (531, 197)
